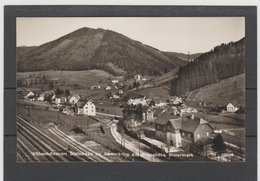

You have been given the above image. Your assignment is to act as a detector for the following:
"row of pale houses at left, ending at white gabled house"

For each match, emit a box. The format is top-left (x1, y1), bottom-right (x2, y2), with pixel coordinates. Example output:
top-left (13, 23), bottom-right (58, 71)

top-left (18, 90), bottom-right (96, 116)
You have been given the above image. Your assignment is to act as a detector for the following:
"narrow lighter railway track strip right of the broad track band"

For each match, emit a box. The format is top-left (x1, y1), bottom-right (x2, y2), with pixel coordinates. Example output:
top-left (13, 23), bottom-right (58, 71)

top-left (49, 127), bottom-right (111, 162)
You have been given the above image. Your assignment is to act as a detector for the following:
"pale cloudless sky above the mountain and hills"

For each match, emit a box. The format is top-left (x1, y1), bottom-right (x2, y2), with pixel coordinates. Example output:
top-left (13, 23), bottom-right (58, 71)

top-left (17, 17), bottom-right (245, 54)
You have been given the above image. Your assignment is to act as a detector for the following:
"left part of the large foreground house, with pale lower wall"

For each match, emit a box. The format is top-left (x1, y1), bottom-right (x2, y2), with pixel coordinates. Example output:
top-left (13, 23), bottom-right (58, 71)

top-left (154, 112), bottom-right (182, 147)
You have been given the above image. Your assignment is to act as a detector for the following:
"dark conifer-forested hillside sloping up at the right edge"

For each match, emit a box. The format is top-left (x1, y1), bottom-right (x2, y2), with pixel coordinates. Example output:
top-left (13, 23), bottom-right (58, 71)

top-left (171, 38), bottom-right (245, 96)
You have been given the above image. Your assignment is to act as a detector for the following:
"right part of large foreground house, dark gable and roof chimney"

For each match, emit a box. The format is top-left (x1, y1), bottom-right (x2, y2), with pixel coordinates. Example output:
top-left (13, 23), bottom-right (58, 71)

top-left (180, 114), bottom-right (214, 147)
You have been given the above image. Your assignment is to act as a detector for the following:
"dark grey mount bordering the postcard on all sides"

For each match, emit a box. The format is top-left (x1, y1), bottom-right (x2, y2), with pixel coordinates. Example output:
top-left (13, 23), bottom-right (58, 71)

top-left (4, 6), bottom-right (257, 180)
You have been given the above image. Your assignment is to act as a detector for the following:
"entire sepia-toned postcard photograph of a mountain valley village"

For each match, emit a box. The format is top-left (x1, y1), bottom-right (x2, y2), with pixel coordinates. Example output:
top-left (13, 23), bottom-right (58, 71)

top-left (16, 17), bottom-right (246, 162)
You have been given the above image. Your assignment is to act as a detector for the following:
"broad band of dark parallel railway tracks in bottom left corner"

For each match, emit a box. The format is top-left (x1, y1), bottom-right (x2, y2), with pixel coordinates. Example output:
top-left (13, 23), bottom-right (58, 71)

top-left (17, 117), bottom-right (88, 162)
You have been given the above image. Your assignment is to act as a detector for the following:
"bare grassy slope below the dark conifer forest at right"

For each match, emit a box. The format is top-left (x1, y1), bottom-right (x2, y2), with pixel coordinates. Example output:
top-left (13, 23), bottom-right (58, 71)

top-left (196, 74), bottom-right (245, 107)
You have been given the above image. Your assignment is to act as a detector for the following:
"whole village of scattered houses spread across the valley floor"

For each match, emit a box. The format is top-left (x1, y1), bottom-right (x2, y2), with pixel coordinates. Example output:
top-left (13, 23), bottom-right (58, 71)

top-left (17, 72), bottom-right (244, 161)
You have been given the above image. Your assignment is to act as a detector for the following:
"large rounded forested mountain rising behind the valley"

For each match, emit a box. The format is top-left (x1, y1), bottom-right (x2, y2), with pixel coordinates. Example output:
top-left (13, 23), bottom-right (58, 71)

top-left (17, 27), bottom-right (185, 78)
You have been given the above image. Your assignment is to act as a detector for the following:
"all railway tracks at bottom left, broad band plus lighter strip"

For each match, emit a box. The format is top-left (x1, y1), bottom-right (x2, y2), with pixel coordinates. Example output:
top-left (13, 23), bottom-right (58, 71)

top-left (17, 117), bottom-right (111, 162)
